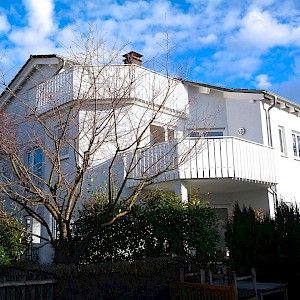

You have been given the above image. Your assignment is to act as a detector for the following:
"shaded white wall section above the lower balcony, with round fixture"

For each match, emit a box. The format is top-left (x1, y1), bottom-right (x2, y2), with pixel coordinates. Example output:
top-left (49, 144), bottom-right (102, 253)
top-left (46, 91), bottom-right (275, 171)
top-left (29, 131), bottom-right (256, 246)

top-left (187, 86), bottom-right (264, 143)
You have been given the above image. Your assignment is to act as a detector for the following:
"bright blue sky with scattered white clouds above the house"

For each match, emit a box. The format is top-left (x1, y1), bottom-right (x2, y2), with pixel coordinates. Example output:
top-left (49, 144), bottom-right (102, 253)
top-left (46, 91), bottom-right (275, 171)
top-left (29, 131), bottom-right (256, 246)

top-left (0, 0), bottom-right (300, 103)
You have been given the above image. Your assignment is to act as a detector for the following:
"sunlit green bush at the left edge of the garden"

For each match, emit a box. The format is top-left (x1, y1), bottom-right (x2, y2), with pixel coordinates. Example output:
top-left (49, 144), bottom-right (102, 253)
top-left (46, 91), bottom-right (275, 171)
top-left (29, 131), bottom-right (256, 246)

top-left (0, 216), bottom-right (29, 265)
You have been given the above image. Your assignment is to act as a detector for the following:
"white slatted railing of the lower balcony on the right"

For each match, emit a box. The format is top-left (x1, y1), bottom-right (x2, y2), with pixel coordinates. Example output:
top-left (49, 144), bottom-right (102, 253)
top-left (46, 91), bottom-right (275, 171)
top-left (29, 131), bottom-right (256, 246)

top-left (126, 137), bottom-right (276, 186)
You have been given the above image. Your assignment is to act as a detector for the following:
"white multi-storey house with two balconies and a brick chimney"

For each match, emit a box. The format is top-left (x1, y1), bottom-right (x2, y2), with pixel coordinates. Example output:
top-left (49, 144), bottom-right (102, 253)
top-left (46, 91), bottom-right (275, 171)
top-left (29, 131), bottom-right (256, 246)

top-left (0, 52), bottom-right (300, 261)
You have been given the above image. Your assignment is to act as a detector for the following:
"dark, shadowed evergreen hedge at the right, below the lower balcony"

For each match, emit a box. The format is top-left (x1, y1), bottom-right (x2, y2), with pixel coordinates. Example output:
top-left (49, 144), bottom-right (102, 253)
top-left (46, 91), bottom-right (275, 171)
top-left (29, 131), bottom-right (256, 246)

top-left (225, 202), bottom-right (300, 280)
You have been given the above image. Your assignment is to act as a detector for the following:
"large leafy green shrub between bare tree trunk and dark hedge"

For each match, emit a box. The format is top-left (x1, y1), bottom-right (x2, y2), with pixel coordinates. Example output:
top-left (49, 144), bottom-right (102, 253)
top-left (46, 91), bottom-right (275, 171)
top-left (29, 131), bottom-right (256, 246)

top-left (76, 192), bottom-right (218, 263)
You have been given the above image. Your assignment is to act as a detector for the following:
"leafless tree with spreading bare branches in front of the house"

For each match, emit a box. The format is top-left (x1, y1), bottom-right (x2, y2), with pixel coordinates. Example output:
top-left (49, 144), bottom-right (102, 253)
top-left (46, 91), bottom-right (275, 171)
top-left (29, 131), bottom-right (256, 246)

top-left (0, 28), bottom-right (208, 262)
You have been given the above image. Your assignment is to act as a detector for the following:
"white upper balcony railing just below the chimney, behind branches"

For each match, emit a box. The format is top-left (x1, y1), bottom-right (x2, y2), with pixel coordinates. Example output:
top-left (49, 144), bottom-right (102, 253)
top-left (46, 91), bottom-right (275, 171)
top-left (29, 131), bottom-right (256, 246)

top-left (36, 65), bottom-right (188, 115)
